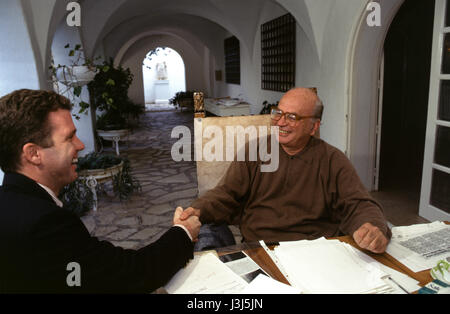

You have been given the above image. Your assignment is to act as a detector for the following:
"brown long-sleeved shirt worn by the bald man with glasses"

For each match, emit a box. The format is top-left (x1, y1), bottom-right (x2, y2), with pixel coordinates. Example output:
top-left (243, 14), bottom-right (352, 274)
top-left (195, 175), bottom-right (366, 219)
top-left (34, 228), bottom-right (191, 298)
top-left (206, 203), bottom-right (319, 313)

top-left (192, 138), bottom-right (391, 241)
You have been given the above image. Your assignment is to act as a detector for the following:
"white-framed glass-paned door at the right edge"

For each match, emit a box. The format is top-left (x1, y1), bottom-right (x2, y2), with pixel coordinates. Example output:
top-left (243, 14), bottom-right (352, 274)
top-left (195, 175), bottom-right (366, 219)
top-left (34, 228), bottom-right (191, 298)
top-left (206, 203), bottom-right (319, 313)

top-left (420, 0), bottom-right (450, 221)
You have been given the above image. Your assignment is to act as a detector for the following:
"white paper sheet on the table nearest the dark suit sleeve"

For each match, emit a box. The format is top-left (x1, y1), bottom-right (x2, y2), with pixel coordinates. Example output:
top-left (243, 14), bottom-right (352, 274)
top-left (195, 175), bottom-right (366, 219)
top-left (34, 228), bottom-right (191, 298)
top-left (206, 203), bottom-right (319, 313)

top-left (164, 253), bottom-right (248, 294)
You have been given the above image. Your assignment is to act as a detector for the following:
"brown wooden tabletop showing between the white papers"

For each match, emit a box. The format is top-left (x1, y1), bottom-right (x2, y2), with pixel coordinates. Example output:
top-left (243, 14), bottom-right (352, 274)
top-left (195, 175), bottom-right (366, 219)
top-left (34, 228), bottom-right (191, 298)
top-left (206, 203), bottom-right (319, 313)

top-left (216, 236), bottom-right (433, 286)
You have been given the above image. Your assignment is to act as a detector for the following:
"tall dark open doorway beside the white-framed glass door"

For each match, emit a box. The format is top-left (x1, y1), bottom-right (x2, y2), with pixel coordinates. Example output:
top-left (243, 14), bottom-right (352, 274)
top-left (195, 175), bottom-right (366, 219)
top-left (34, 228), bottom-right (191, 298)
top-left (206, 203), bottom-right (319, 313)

top-left (378, 0), bottom-right (435, 221)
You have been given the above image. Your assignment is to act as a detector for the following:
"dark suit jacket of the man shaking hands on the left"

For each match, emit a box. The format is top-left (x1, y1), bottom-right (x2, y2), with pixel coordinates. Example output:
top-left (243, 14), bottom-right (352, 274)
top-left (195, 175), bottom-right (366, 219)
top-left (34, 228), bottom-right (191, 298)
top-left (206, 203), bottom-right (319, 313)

top-left (0, 173), bottom-right (193, 293)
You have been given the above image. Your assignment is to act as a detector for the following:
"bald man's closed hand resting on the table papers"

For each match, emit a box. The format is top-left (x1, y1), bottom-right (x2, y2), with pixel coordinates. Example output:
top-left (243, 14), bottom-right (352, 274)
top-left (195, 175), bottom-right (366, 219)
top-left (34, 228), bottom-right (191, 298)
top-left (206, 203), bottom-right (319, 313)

top-left (353, 223), bottom-right (389, 253)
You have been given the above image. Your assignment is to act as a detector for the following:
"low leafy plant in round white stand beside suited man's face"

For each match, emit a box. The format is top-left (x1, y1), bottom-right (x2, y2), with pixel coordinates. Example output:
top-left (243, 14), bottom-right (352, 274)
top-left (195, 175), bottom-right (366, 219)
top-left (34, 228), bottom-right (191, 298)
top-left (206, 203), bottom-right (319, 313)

top-left (60, 152), bottom-right (141, 216)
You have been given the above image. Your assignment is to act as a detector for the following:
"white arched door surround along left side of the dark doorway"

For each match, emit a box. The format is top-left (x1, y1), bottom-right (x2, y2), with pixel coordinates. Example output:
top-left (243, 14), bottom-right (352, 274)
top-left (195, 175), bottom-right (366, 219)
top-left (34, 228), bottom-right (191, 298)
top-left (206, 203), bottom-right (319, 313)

top-left (347, 0), bottom-right (404, 189)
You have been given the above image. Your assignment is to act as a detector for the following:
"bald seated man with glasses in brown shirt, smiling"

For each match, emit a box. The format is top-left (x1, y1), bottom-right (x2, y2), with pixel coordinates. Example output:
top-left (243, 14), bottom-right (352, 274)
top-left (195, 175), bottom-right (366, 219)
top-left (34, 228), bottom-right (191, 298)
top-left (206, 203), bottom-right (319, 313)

top-left (181, 88), bottom-right (391, 253)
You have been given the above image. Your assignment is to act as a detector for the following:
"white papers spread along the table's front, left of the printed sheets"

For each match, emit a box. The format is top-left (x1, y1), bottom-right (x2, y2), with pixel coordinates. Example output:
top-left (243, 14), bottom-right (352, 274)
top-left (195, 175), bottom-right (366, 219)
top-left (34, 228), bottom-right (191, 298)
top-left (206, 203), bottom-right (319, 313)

top-left (165, 238), bottom-right (420, 294)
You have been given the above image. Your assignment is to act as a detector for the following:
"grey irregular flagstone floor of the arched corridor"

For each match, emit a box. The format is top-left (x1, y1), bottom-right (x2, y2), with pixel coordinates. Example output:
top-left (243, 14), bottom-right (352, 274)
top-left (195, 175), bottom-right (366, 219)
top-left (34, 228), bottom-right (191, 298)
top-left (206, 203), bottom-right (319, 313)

top-left (82, 110), bottom-right (424, 249)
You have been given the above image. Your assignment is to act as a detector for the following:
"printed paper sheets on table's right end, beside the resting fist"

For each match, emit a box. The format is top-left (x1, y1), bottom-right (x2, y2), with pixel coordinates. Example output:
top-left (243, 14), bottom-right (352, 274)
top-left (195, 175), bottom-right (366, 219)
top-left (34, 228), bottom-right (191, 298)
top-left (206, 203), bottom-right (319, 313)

top-left (386, 221), bottom-right (450, 272)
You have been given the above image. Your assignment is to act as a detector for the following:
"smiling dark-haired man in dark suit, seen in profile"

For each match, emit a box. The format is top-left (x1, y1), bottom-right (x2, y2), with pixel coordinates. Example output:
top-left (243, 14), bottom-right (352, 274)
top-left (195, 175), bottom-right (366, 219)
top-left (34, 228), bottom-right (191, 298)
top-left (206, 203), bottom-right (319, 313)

top-left (0, 90), bottom-right (200, 293)
